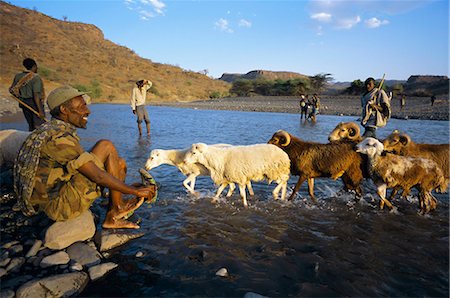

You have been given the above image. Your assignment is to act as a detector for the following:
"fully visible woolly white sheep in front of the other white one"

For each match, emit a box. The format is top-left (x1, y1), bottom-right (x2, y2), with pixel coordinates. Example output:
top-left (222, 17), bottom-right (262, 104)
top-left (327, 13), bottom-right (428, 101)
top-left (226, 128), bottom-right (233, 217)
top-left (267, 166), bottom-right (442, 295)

top-left (185, 143), bottom-right (290, 207)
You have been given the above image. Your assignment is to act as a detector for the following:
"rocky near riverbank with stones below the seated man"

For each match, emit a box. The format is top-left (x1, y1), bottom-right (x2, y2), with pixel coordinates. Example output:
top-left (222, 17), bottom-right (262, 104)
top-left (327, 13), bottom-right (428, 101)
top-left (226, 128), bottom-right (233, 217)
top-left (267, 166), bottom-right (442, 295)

top-left (0, 177), bottom-right (149, 298)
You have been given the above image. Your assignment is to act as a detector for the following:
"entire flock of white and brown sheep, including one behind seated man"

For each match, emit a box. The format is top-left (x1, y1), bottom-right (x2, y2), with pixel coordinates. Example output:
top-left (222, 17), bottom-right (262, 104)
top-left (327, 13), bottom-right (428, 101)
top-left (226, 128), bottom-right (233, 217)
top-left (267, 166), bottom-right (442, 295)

top-left (0, 122), bottom-right (450, 213)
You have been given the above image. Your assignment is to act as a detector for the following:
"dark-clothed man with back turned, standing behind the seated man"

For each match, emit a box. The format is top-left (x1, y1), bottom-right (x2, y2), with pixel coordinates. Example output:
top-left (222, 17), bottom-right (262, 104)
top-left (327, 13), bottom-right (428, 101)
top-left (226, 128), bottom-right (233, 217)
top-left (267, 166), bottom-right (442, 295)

top-left (9, 58), bottom-right (45, 131)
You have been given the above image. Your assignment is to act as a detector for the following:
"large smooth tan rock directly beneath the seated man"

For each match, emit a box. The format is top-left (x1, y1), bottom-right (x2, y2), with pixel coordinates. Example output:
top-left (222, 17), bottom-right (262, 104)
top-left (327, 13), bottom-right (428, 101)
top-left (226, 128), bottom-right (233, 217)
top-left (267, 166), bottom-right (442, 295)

top-left (44, 210), bottom-right (95, 249)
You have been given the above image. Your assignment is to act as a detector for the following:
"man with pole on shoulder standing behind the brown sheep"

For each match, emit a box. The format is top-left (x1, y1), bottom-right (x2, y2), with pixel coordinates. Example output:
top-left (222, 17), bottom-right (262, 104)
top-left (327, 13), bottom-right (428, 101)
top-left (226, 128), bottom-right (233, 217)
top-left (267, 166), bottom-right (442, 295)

top-left (361, 76), bottom-right (391, 138)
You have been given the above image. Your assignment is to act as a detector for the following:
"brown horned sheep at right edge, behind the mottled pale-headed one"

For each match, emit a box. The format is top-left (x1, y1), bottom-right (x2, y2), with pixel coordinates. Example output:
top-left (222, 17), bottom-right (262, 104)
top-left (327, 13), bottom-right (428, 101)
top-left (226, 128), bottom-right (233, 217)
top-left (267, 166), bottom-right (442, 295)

top-left (383, 130), bottom-right (450, 185)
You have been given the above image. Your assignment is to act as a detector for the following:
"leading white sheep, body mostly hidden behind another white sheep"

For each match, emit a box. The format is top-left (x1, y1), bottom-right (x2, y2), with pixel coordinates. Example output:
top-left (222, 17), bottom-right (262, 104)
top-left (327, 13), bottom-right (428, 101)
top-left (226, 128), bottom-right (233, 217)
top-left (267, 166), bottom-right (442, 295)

top-left (145, 144), bottom-right (253, 197)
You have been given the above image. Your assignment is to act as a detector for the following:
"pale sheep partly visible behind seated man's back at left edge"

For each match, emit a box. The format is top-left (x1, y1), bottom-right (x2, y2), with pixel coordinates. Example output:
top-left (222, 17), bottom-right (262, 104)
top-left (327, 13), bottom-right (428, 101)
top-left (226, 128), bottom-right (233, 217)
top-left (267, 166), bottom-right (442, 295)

top-left (0, 129), bottom-right (30, 170)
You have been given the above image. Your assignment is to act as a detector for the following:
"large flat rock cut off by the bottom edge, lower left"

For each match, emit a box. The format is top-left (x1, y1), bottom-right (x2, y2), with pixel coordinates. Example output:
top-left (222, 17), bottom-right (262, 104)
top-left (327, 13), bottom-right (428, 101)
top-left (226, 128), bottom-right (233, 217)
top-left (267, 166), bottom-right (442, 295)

top-left (16, 272), bottom-right (89, 298)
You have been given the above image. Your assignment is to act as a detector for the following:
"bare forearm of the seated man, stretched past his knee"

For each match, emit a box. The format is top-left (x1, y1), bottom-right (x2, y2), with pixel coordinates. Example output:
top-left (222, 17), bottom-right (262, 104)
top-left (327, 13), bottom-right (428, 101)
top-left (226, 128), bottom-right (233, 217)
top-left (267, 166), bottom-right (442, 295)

top-left (78, 161), bottom-right (154, 197)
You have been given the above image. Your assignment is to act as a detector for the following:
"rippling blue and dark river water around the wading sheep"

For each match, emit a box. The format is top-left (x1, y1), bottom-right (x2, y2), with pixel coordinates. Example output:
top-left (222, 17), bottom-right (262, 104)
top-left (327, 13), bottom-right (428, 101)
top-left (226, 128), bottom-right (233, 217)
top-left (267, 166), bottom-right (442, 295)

top-left (2, 105), bottom-right (449, 297)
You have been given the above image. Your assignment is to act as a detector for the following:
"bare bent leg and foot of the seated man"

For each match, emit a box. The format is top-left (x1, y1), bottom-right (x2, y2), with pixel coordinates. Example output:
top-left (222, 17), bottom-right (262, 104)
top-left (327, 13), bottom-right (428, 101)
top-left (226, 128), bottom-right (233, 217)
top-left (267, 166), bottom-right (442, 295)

top-left (91, 140), bottom-right (144, 229)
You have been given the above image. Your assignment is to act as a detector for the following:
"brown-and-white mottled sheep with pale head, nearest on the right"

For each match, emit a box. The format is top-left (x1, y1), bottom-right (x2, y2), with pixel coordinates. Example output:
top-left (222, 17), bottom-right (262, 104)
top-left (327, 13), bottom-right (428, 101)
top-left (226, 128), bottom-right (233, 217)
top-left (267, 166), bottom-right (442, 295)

top-left (357, 138), bottom-right (447, 213)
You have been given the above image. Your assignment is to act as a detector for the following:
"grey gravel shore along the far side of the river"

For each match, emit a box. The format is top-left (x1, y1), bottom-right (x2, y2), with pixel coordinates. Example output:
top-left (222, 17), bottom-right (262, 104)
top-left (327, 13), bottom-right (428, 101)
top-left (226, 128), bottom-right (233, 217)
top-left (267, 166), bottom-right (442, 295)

top-left (0, 94), bottom-right (449, 122)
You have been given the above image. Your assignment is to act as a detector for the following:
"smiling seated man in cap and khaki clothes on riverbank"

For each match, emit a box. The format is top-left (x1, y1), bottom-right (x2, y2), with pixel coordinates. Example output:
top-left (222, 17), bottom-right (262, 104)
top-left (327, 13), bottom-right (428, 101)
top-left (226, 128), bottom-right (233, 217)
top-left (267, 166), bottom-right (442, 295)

top-left (14, 86), bottom-right (156, 229)
